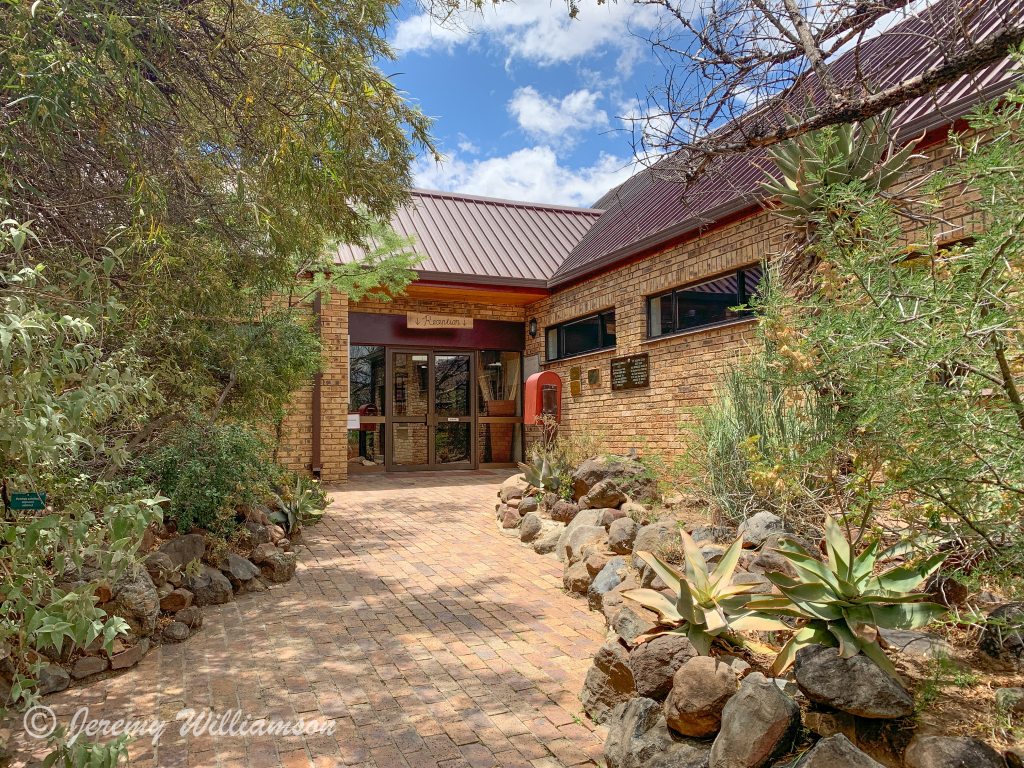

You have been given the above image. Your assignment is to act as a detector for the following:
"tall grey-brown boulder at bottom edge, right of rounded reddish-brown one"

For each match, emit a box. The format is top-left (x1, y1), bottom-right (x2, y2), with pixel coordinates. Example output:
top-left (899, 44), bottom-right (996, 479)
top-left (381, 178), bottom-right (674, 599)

top-left (708, 672), bottom-right (800, 768)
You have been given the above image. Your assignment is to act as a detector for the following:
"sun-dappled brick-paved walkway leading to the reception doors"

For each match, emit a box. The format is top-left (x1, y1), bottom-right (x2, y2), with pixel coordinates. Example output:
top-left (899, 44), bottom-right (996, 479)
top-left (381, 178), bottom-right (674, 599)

top-left (9, 471), bottom-right (604, 768)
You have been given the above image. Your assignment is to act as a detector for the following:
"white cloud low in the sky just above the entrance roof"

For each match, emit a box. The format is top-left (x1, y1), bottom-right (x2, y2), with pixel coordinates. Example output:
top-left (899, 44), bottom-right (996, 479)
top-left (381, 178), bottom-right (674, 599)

top-left (416, 145), bottom-right (634, 206)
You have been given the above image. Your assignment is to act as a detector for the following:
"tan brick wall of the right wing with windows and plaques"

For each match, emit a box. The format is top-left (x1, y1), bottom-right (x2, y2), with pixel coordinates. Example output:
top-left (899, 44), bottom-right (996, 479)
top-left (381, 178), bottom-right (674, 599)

top-left (526, 128), bottom-right (978, 463)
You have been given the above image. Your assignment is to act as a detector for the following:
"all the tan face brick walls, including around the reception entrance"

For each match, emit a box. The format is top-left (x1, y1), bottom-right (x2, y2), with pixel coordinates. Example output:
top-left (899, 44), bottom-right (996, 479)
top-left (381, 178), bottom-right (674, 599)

top-left (279, 129), bottom-right (980, 482)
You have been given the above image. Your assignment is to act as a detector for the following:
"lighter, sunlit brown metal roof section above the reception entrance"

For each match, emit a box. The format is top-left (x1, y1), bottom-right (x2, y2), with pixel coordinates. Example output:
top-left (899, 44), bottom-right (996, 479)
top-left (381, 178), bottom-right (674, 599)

top-left (336, 189), bottom-right (602, 287)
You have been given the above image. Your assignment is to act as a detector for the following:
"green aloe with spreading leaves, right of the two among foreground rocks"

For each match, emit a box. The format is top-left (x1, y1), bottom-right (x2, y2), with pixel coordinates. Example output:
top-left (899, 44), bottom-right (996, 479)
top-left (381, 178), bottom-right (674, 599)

top-left (748, 515), bottom-right (946, 684)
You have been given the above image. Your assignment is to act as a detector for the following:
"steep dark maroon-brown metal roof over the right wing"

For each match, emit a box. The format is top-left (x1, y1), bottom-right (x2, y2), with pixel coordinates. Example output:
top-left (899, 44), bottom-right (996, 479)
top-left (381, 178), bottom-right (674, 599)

top-left (549, 0), bottom-right (1024, 287)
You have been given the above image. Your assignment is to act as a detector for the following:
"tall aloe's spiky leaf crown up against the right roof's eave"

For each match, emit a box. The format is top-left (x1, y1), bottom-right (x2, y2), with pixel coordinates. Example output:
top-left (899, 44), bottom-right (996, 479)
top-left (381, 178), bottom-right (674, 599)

top-left (762, 110), bottom-right (920, 234)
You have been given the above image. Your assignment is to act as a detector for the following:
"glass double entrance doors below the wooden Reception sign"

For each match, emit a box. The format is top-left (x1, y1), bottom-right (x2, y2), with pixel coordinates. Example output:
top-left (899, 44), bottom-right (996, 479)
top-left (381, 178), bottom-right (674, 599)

top-left (387, 349), bottom-right (476, 471)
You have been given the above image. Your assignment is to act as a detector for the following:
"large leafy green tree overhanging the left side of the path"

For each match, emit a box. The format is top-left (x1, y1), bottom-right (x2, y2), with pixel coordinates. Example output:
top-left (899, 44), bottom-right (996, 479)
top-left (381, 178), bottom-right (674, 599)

top-left (0, 0), bottom-right (433, 445)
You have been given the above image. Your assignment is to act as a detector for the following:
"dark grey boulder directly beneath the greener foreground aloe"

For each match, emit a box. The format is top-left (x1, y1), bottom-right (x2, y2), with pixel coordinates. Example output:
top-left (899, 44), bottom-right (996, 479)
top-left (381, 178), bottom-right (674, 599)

top-left (795, 645), bottom-right (913, 718)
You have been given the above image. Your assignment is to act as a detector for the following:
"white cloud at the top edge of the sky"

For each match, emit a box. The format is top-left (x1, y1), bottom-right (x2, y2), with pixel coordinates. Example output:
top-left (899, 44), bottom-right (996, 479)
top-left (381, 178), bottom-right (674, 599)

top-left (391, 0), bottom-right (657, 66)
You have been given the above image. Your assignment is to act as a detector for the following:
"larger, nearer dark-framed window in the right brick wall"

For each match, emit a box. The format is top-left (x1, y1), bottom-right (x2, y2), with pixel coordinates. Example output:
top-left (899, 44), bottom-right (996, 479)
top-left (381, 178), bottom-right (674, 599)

top-left (647, 266), bottom-right (762, 339)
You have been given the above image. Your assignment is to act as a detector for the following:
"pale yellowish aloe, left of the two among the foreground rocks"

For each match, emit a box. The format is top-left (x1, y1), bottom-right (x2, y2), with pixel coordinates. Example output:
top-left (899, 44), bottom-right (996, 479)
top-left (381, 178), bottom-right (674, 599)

top-left (623, 531), bottom-right (790, 656)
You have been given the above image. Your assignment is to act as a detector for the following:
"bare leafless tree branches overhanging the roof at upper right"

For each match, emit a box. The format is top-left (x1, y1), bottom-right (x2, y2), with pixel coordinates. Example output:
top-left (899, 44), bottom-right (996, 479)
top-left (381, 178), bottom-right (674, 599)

top-left (634, 0), bottom-right (1024, 183)
